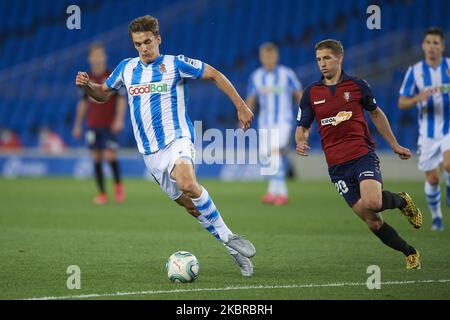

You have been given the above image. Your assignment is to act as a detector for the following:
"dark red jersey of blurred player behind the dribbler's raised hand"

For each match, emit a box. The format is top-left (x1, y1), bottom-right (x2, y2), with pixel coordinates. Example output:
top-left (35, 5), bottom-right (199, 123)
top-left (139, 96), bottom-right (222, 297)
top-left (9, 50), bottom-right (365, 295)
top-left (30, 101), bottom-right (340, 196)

top-left (85, 71), bottom-right (117, 129)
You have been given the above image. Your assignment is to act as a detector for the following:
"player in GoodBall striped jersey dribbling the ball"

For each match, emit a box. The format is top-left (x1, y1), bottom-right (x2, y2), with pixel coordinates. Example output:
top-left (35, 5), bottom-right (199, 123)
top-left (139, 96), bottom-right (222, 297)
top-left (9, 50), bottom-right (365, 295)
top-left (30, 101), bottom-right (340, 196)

top-left (76, 16), bottom-right (256, 276)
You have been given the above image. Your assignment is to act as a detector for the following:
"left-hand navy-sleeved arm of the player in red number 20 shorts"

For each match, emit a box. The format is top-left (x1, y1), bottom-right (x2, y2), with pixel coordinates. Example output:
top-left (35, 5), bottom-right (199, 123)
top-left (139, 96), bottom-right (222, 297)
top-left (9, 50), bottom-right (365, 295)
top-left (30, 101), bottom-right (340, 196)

top-left (295, 87), bottom-right (314, 156)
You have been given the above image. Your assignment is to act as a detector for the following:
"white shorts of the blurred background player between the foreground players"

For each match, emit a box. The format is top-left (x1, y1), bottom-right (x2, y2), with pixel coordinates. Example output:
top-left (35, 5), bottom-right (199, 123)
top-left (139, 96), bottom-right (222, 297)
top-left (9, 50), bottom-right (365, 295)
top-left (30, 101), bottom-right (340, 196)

top-left (259, 124), bottom-right (292, 156)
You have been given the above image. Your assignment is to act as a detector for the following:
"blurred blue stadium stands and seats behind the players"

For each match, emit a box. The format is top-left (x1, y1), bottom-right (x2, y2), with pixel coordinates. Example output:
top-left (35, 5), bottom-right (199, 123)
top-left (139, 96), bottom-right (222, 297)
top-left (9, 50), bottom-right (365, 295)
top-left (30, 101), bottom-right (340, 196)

top-left (0, 0), bottom-right (450, 177)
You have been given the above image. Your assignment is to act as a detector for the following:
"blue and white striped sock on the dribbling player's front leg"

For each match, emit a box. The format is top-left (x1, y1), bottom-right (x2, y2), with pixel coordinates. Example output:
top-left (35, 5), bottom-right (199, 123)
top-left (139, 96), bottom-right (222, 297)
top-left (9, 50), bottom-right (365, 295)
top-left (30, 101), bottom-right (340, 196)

top-left (192, 187), bottom-right (232, 242)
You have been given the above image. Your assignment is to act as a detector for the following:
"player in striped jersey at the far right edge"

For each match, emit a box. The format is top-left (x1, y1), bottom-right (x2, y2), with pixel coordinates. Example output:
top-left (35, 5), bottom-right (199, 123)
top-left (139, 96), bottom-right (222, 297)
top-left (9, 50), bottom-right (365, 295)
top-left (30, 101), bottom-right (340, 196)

top-left (399, 28), bottom-right (450, 231)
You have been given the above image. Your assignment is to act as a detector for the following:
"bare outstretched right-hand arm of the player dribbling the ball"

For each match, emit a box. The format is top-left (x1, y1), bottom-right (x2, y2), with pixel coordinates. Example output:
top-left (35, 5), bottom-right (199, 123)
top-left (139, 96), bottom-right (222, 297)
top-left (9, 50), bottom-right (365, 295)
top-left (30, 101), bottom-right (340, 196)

top-left (201, 63), bottom-right (253, 130)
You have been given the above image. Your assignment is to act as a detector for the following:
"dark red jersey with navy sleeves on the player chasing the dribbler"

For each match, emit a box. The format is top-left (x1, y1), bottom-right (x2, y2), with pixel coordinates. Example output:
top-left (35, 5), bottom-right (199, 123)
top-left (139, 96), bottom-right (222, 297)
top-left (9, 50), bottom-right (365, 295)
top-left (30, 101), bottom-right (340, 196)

top-left (297, 73), bottom-right (377, 167)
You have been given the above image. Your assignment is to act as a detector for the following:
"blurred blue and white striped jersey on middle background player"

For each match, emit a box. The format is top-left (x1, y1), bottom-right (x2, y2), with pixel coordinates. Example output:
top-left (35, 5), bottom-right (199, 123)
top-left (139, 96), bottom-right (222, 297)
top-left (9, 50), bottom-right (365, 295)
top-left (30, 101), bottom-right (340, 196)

top-left (247, 65), bottom-right (302, 128)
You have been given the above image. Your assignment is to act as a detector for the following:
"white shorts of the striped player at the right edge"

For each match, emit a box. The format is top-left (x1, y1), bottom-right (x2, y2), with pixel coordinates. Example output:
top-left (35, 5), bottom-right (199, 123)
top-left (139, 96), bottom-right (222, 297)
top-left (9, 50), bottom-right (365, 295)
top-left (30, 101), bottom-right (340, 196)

top-left (417, 134), bottom-right (450, 171)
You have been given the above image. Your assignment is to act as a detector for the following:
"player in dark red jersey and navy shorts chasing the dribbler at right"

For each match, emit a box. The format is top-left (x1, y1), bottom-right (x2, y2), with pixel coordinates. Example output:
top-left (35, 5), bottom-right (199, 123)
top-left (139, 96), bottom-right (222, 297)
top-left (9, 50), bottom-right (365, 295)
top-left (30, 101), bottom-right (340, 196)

top-left (295, 39), bottom-right (422, 269)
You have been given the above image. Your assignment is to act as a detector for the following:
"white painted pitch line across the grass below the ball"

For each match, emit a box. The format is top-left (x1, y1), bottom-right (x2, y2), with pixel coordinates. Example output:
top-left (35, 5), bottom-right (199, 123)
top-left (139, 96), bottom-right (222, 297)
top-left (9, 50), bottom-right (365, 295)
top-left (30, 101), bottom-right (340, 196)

top-left (25, 279), bottom-right (450, 300)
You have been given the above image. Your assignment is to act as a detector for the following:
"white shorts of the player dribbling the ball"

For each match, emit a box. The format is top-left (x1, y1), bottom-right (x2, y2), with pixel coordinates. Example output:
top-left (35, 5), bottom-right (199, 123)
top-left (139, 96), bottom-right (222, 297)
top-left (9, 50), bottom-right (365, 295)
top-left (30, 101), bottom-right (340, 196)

top-left (143, 137), bottom-right (195, 200)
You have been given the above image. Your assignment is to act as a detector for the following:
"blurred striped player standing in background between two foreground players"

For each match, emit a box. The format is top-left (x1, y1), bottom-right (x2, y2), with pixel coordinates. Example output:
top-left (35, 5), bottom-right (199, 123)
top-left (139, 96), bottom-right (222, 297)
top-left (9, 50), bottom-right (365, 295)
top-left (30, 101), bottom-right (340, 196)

top-left (246, 43), bottom-right (302, 206)
